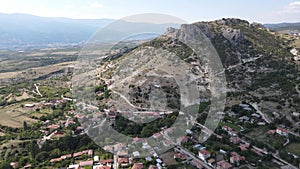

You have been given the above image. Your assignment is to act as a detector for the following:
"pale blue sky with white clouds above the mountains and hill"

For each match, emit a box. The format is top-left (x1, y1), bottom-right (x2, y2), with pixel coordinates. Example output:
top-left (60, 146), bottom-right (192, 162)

top-left (0, 0), bottom-right (300, 23)
